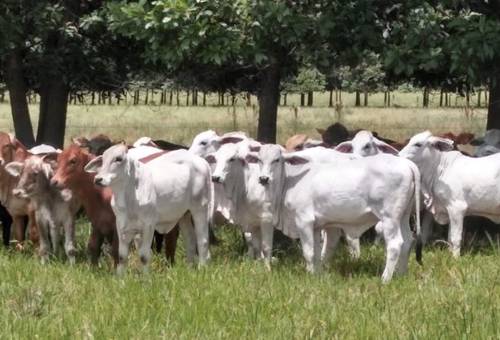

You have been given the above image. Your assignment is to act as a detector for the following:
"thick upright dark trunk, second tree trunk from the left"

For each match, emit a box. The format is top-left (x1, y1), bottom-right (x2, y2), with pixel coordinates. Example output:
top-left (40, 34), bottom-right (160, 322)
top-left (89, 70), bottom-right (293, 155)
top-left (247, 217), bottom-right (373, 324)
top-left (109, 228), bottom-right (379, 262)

top-left (36, 74), bottom-right (68, 148)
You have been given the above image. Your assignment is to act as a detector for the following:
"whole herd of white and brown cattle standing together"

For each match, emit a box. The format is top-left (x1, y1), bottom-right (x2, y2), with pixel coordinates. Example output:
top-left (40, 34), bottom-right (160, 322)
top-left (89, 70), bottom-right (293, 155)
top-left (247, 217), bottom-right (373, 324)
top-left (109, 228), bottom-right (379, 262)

top-left (0, 123), bottom-right (500, 282)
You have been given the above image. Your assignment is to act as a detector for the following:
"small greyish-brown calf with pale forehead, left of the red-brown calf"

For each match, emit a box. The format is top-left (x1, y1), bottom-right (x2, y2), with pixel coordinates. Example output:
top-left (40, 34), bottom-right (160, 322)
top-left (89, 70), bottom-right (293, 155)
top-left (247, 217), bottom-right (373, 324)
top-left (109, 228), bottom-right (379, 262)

top-left (5, 156), bottom-right (79, 264)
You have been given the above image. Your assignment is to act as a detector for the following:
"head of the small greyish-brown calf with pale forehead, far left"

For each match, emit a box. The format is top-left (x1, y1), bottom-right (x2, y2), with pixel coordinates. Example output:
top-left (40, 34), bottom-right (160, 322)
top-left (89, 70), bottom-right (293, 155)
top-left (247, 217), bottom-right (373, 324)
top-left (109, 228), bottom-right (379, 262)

top-left (5, 156), bottom-right (54, 198)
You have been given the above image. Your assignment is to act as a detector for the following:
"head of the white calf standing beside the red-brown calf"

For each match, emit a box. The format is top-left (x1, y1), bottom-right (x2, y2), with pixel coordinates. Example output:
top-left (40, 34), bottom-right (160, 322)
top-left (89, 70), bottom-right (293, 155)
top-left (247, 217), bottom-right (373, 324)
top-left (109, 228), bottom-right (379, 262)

top-left (85, 144), bottom-right (128, 186)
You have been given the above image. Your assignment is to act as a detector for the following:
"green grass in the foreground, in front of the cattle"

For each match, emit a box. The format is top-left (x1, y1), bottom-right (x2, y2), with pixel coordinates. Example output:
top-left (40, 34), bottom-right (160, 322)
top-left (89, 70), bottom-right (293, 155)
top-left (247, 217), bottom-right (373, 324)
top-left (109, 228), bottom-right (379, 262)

top-left (0, 222), bottom-right (500, 339)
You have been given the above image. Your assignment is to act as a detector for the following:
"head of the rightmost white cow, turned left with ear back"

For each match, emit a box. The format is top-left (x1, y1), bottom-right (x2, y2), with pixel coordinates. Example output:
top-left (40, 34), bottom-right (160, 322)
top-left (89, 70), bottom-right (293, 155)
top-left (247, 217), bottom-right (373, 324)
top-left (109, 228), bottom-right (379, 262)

top-left (399, 131), bottom-right (453, 163)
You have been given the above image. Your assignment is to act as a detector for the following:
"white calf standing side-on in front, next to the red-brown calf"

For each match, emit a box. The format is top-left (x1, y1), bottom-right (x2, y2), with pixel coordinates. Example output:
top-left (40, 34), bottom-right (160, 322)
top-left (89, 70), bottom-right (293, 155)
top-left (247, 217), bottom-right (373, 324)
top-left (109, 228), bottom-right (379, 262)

top-left (85, 144), bottom-right (213, 274)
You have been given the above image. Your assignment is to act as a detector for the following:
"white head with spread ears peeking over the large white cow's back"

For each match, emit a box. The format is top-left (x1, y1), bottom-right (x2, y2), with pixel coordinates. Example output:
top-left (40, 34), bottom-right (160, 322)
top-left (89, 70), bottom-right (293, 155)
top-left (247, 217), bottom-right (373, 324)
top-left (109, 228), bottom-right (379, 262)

top-left (335, 130), bottom-right (398, 157)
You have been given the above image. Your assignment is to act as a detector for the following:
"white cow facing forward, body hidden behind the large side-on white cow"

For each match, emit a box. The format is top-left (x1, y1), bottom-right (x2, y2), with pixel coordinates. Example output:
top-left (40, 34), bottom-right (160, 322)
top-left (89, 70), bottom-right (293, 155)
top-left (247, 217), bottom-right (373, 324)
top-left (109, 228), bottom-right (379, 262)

top-left (206, 142), bottom-right (279, 270)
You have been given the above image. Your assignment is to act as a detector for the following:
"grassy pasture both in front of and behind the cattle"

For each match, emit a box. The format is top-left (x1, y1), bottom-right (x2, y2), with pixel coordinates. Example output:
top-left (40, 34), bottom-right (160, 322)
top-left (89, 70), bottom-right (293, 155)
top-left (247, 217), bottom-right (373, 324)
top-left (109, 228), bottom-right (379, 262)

top-left (0, 104), bottom-right (500, 339)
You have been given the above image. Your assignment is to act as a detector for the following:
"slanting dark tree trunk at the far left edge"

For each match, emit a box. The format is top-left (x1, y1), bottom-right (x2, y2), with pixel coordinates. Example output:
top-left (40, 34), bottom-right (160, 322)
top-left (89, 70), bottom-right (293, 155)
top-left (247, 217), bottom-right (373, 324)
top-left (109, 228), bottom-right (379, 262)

top-left (5, 50), bottom-right (35, 147)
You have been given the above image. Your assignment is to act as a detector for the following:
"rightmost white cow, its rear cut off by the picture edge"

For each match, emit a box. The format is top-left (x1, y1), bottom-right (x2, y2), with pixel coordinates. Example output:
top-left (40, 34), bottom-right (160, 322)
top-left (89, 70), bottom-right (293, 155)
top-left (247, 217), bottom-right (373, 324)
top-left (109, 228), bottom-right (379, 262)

top-left (400, 131), bottom-right (500, 257)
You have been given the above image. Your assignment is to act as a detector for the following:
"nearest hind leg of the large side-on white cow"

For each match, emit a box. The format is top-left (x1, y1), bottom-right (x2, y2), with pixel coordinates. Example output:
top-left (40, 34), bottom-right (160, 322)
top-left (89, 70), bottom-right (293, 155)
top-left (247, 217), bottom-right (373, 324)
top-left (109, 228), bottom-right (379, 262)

top-left (381, 219), bottom-right (403, 283)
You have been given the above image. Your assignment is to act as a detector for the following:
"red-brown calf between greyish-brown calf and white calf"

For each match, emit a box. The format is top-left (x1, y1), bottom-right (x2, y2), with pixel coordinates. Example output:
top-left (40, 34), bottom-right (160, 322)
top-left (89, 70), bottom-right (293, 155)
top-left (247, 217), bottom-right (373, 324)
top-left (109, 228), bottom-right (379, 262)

top-left (51, 144), bottom-right (118, 265)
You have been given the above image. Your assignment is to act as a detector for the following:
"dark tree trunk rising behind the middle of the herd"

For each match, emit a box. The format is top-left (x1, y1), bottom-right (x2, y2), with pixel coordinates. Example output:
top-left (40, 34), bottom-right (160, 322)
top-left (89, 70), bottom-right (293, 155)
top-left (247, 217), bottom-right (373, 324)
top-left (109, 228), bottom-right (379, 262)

top-left (257, 64), bottom-right (281, 143)
